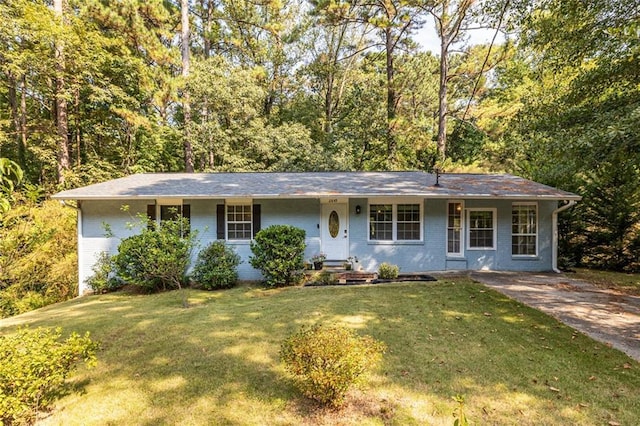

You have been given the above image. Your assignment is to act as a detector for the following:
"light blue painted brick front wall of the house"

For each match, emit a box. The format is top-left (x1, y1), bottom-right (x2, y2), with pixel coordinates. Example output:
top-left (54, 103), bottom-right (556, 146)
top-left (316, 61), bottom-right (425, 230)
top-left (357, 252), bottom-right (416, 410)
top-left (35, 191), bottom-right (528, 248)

top-left (78, 197), bottom-right (558, 294)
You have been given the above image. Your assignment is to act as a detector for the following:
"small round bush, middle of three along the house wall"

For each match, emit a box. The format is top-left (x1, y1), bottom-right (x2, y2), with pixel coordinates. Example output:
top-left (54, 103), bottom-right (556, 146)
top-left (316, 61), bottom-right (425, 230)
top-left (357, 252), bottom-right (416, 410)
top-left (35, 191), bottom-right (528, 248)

top-left (191, 240), bottom-right (241, 290)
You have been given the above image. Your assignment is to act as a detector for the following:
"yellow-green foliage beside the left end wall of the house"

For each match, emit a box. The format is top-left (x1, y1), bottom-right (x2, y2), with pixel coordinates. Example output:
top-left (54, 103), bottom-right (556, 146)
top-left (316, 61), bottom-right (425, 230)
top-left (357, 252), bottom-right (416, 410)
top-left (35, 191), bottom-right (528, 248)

top-left (0, 201), bottom-right (78, 317)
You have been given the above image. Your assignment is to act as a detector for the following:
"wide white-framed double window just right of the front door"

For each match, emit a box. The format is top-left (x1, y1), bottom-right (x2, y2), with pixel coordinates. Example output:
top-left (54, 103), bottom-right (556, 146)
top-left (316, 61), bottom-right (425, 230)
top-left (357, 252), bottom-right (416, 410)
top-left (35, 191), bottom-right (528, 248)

top-left (369, 204), bottom-right (422, 241)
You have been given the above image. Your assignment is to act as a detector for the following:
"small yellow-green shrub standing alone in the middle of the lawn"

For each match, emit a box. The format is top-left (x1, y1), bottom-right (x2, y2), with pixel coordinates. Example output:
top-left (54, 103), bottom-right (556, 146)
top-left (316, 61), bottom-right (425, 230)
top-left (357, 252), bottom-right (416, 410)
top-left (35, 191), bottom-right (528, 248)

top-left (280, 325), bottom-right (386, 407)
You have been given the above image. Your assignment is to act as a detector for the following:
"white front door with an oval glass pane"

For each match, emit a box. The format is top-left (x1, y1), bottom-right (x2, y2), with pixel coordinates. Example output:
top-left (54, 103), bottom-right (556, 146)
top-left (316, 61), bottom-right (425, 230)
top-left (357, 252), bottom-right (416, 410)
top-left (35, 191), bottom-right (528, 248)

top-left (320, 203), bottom-right (349, 260)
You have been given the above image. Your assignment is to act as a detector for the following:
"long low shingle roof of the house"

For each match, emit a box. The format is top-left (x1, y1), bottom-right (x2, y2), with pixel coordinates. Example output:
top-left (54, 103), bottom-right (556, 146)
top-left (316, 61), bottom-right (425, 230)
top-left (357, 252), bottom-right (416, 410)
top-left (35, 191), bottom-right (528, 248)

top-left (53, 172), bottom-right (580, 200)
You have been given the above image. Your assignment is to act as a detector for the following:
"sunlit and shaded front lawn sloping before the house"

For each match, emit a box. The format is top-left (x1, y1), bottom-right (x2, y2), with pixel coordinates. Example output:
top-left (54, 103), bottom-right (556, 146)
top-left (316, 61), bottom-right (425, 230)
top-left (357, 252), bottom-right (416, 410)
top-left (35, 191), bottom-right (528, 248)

top-left (0, 278), bottom-right (640, 425)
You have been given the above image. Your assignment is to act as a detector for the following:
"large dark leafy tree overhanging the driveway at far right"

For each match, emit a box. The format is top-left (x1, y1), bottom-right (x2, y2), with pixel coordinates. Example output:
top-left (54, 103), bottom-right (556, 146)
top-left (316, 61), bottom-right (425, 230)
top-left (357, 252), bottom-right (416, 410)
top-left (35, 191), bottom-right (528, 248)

top-left (484, 0), bottom-right (640, 270)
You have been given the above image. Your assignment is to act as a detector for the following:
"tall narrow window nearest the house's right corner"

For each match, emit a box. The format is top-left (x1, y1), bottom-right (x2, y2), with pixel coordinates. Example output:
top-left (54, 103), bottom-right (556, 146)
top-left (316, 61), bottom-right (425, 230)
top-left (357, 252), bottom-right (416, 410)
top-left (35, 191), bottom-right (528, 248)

top-left (511, 203), bottom-right (538, 256)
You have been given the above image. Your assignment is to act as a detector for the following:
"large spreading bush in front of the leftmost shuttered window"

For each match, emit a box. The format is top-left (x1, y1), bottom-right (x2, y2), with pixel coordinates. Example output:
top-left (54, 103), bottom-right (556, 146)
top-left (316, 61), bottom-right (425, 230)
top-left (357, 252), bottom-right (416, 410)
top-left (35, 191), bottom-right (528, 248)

top-left (113, 217), bottom-right (196, 292)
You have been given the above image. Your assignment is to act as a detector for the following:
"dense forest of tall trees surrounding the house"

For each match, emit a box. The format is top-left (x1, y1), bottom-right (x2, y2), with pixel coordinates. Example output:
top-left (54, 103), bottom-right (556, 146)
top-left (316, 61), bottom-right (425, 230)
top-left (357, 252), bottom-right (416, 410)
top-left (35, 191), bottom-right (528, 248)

top-left (0, 0), bottom-right (640, 316)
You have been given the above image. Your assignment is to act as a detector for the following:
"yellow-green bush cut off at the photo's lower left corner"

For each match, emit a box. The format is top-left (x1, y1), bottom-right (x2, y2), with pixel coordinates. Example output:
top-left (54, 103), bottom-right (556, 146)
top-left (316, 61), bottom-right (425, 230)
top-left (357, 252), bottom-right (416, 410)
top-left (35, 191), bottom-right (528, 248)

top-left (0, 328), bottom-right (99, 425)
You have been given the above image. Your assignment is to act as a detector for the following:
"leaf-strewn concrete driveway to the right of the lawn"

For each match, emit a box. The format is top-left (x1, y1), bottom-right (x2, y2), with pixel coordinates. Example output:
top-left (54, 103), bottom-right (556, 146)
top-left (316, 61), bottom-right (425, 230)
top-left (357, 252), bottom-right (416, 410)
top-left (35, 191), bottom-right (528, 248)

top-left (471, 272), bottom-right (640, 361)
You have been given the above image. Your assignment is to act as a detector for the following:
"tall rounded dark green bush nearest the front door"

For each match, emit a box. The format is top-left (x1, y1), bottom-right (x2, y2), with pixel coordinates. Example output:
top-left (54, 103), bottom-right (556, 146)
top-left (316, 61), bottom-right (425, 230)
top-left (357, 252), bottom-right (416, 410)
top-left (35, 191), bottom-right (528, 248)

top-left (249, 225), bottom-right (306, 287)
